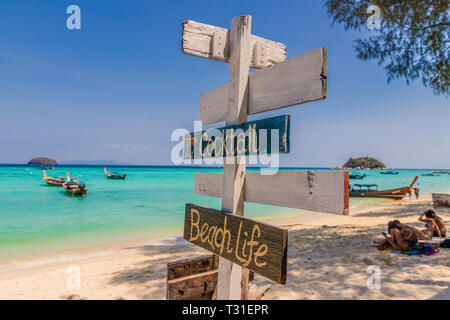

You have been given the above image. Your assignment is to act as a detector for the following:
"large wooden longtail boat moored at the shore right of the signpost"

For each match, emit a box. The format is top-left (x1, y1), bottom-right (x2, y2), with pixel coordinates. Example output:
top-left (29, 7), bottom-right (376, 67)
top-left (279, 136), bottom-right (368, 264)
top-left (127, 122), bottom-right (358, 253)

top-left (350, 176), bottom-right (419, 200)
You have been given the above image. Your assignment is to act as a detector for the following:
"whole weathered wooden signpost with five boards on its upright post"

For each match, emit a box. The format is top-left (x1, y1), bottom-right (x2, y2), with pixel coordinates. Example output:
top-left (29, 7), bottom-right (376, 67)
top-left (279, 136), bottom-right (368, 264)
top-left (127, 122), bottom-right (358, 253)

top-left (175, 16), bottom-right (348, 300)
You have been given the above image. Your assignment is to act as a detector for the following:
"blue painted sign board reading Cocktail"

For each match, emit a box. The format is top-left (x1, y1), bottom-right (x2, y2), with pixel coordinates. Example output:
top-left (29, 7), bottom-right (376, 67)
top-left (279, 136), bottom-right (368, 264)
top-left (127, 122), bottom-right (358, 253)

top-left (184, 116), bottom-right (290, 160)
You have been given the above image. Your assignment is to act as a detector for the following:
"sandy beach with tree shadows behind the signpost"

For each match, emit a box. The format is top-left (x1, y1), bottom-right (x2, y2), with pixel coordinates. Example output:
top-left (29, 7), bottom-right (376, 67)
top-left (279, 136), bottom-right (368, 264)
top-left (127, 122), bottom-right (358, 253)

top-left (0, 197), bottom-right (450, 299)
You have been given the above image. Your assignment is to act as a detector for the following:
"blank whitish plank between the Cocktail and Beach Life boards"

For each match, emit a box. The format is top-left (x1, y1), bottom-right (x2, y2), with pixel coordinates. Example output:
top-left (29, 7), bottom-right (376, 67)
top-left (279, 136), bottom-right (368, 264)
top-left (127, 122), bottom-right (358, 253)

top-left (195, 171), bottom-right (349, 215)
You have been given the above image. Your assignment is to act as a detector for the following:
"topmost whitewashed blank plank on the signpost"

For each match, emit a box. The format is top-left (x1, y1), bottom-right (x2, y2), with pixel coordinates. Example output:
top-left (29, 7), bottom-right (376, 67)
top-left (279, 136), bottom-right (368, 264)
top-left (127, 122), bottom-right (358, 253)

top-left (182, 20), bottom-right (286, 69)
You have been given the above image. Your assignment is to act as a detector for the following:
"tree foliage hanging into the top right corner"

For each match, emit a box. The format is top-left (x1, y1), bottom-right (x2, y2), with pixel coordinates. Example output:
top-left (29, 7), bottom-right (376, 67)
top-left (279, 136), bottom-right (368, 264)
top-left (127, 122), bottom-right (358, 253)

top-left (325, 0), bottom-right (450, 97)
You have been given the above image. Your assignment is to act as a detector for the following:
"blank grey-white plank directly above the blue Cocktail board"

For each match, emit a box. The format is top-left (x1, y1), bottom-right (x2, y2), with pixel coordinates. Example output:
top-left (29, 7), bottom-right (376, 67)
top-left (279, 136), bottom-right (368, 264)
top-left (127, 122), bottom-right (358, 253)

top-left (200, 47), bottom-right (327, 124)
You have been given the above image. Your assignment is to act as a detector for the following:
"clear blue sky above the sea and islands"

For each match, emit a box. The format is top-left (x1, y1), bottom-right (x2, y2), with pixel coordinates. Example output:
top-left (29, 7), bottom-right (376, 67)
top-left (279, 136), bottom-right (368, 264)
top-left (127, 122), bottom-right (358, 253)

top-left (0, 0), bottom-right (450, 168)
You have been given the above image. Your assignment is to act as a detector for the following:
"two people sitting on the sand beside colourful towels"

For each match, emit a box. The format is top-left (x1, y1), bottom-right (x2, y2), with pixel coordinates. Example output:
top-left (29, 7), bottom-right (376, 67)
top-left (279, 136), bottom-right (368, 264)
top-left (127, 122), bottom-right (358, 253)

top-left (377, 210), bottom-right (447, 251)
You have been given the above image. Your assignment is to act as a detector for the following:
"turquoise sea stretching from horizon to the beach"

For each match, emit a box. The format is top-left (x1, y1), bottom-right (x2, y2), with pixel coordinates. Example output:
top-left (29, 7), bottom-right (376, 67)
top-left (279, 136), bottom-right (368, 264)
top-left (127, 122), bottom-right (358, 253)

top-left (0, 165), bottom-right (450, 263)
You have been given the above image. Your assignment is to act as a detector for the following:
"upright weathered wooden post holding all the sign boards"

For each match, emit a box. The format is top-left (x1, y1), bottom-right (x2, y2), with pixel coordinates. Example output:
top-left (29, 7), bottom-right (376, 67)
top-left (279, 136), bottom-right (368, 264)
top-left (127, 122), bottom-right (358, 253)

top-left (217, 16), bottom-right (252, 300)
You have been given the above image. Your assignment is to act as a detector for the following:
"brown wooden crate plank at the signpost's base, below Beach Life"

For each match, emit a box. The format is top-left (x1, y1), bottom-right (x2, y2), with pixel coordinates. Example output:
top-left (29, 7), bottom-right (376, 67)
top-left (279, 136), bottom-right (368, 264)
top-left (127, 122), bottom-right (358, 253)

top-left (167, 270), bottom-right (219, 300)
